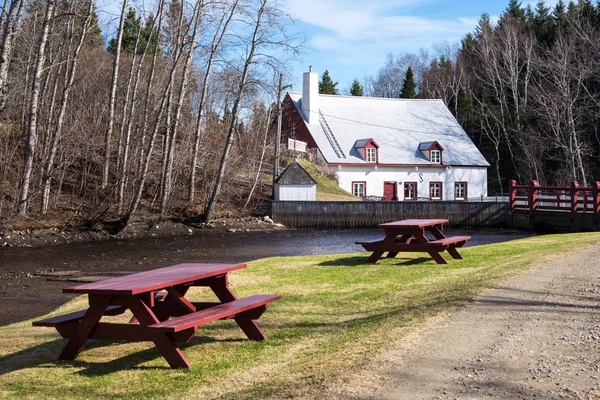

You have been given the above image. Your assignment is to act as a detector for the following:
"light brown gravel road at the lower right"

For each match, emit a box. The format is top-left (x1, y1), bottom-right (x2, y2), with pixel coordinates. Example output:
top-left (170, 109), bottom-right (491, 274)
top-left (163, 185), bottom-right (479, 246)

top-left (352, 245), bottom-right (600, 400)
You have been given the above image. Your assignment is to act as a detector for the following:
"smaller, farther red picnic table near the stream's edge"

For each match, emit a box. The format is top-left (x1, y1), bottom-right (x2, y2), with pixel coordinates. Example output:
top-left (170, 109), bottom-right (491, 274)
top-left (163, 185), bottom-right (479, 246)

top-left (356, 219), bottom-right (471, 264)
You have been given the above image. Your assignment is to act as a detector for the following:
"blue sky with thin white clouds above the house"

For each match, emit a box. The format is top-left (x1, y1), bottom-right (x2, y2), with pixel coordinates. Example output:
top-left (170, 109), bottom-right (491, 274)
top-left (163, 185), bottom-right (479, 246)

top-left (286, 0), bottom-right (557, 92)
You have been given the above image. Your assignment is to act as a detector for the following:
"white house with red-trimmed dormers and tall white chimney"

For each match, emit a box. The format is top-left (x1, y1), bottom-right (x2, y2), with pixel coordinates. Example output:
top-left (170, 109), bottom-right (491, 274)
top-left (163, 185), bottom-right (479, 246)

top-left (282, 71), bottom-right (490, 201)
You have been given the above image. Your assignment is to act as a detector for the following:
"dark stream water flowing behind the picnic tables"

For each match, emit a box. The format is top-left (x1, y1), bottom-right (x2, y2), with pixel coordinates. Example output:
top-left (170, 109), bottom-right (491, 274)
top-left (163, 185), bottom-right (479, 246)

top-left (0, 229), bottom-right (535, 326)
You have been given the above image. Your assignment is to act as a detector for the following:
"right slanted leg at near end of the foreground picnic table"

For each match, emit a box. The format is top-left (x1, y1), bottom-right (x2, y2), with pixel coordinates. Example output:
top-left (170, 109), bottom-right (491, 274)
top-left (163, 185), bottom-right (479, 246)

top-left (129, 297), bottom-right (192, 369)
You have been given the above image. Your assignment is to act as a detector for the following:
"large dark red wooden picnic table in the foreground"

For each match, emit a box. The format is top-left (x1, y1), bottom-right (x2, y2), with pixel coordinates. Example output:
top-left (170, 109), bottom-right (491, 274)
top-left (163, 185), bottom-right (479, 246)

top-left (33, 264), bottom-right (281, 368)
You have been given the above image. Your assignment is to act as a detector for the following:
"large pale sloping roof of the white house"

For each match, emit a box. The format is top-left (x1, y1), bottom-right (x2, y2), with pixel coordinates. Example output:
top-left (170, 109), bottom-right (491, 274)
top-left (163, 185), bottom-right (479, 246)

top-left (288, 92), bottom-right (490, 167)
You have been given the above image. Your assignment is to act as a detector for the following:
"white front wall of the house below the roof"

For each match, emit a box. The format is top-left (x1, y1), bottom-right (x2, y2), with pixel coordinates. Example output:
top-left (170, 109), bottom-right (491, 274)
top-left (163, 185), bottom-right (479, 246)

top-left (331, 165), bottom-right (487, 201)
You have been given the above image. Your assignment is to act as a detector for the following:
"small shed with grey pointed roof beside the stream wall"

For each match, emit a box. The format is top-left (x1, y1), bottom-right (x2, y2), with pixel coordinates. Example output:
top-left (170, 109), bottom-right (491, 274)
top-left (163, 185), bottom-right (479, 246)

top-left (275, 161), bottom-right (317, 201)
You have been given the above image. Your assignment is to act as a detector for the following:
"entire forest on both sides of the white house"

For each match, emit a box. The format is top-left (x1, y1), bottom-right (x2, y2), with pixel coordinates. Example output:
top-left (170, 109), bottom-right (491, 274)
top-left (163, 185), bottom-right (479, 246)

top-left (0, 0), bottom-right (600, 227)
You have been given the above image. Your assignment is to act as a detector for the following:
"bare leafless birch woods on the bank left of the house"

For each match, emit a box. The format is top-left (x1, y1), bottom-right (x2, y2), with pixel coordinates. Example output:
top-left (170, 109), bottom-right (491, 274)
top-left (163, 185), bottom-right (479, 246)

top-left (0, 0), bottom-right (302, 227)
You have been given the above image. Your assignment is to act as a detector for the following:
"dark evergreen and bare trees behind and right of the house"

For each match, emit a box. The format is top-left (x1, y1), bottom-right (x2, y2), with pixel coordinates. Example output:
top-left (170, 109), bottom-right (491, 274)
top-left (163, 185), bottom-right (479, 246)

top-left (349, 0), bottom-right (600, 194)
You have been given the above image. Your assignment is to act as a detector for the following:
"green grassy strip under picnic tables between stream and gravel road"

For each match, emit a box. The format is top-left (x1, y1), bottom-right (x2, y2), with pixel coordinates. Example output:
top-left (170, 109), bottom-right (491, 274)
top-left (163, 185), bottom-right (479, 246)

top-left (0, 233), bottom-right (600, 399)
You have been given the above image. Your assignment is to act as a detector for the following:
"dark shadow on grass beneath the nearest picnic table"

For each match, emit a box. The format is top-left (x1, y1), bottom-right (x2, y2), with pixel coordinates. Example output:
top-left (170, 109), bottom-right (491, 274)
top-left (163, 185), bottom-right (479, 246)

top-left (0, 336), bottom-right (248, 376)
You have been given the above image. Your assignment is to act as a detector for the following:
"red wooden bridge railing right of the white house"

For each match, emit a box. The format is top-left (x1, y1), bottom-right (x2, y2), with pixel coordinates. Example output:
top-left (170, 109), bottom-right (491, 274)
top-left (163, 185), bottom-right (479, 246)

top-left (508, 180), bottom-right (600, 221)
